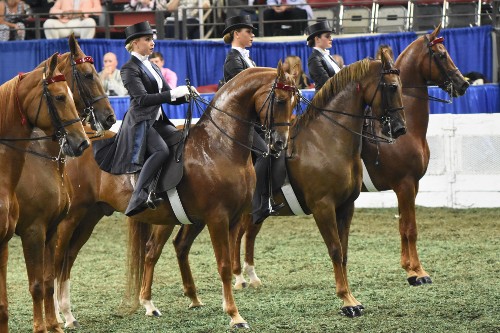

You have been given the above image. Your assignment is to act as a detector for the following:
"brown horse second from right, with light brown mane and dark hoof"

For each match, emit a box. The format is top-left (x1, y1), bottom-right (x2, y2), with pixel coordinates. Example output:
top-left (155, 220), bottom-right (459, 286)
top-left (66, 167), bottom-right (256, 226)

top-left (143, 53), bottom-right (406, 317)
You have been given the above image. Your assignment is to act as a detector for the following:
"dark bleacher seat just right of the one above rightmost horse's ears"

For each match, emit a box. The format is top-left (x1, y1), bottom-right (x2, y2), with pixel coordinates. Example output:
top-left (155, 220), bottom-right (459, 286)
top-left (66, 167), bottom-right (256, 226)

top-left (445, 0), bottom-right (481, 28)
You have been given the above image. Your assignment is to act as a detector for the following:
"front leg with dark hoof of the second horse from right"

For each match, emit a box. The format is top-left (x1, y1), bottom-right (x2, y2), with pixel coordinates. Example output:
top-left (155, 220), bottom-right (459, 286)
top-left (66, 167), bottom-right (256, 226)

top-left (313, 203), bottom-right (359, 317)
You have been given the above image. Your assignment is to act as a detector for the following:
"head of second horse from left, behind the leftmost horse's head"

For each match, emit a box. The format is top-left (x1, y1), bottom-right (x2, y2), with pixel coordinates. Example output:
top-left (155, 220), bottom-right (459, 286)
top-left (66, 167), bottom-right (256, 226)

top-left (66, 34), bottom-right (116, 132)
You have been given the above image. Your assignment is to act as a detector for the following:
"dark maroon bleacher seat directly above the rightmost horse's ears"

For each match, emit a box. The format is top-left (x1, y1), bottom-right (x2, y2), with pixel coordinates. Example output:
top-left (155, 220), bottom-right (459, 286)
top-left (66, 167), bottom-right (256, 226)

top-left (411, 0), bottom-right (444, 31)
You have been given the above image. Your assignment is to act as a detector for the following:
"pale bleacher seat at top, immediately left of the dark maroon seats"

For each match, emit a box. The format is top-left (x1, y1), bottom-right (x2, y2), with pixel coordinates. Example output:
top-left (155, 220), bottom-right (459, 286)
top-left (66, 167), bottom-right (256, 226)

top-left (374, 0), bottom-right (411, 32)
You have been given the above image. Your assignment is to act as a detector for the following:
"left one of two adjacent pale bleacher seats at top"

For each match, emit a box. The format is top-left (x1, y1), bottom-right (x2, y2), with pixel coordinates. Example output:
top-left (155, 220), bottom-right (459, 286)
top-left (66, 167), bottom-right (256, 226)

top-left (340, 0), bottom-right (374, 34)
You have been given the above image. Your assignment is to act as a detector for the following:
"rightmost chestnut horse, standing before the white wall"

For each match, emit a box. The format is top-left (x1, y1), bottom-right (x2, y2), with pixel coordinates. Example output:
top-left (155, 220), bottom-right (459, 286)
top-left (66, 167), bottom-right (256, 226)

top-left (233, 26), bottom-right (469, 289)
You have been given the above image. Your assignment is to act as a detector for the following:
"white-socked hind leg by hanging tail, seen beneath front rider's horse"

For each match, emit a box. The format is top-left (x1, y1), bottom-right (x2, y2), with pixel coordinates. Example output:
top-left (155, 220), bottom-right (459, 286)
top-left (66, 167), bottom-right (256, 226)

top-left (139, 225), bottom-right (174, 317)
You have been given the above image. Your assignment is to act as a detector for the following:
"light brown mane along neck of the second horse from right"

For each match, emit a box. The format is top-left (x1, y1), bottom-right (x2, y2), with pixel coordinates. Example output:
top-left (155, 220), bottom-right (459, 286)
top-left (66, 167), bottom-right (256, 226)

top-left (301, 58), bottom-right (371, 126)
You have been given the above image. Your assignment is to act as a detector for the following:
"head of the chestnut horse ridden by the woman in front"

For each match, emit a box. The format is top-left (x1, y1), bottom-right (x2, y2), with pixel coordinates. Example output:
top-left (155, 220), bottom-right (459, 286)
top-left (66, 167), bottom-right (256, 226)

top-left (255, 60), bottom-right (298, 153)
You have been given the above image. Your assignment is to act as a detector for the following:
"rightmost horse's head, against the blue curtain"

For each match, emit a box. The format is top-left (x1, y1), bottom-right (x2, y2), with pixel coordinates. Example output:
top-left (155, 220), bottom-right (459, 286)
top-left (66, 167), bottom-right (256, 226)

top-left (421, 24), bottom-right (469, 97)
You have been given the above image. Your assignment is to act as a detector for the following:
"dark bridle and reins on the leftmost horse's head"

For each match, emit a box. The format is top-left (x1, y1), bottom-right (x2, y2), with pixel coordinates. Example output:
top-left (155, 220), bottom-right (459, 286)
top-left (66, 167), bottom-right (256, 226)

top-left (0, 64), bottom-right (81, 161)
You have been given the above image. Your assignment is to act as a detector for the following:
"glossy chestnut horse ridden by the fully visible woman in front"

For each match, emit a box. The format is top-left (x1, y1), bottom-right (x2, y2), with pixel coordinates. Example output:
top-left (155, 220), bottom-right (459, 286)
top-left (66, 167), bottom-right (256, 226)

top-left (50, 62), bottom-right (297, 327)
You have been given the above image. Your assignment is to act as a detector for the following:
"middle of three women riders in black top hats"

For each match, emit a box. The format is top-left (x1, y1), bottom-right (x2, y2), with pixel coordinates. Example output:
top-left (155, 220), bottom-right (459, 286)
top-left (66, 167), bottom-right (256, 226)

top-left (223, 15), bottom-right (284, 224)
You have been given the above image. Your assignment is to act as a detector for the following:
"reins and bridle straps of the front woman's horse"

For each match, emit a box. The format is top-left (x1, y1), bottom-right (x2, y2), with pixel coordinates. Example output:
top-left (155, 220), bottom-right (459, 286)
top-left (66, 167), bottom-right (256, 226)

top-left (186, 77), bottom-right (297, 157)
